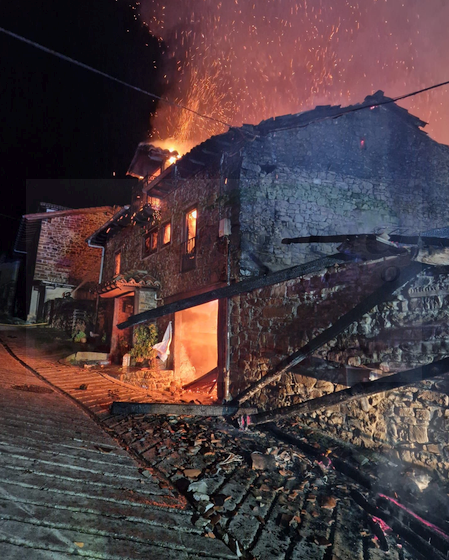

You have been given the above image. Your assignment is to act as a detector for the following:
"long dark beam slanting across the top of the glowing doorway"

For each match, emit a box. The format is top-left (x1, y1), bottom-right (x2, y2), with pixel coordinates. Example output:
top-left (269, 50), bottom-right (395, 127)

top-left (117, 254), bottom-right (344, 329)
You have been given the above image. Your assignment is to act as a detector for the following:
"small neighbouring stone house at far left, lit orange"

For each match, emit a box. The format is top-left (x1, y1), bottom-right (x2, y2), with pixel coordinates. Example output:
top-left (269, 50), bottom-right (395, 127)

top-left (14, 203), bottom-right (114, 323)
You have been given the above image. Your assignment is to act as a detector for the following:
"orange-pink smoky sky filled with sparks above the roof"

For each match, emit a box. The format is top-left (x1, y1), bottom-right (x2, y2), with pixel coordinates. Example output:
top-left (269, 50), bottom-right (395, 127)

top-left (131, 0), bottom-right (449, 146)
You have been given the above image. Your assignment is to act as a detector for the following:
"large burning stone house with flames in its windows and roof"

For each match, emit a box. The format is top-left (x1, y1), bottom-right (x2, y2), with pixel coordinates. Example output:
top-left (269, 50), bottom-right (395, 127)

top-left (90, 92), bottom-right (449, 473)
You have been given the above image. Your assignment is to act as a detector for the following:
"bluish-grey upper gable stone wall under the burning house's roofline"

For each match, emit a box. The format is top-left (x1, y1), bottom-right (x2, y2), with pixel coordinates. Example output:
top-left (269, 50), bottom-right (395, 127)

top-left (240, 107), bottom-right (449, 275)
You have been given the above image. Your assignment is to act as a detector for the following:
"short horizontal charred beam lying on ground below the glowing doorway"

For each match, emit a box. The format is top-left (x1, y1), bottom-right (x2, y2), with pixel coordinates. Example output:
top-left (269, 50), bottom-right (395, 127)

top-left (111, 401), bottom-right (257, 416)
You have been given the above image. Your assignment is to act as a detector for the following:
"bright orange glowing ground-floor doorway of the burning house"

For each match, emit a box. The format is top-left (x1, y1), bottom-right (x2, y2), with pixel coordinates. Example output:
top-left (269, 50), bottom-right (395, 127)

top-left (173, 300), bottom-right (218, 397)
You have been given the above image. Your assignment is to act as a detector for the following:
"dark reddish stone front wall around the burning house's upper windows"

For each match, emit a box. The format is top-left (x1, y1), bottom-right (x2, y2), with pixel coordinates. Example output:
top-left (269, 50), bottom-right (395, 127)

top-left (103, 165), bottom-right (238, 298)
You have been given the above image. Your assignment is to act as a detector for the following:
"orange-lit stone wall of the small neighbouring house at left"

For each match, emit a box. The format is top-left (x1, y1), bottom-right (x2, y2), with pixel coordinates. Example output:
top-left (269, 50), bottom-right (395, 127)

top-left (34, 207), bottom-right (113, 286)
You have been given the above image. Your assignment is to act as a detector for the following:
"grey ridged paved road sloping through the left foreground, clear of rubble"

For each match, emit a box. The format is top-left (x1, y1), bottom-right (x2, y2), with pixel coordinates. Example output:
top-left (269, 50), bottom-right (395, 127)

top-left (0, 345), bottom-right (235, 560)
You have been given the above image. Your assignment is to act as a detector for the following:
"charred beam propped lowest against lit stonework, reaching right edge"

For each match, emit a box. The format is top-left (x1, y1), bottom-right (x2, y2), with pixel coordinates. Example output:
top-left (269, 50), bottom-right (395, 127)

top-left (238, 358), bottom-right (449, 425)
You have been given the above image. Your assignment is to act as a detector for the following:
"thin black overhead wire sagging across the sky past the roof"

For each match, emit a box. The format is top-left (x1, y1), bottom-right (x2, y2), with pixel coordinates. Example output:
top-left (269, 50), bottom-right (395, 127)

top-left (0, 27), bottom-right (449, 139)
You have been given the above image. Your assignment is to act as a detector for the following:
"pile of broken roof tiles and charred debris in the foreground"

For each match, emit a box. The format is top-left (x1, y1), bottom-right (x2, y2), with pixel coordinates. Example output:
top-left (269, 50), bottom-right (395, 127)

top-left (101, 415), bottom-right (438, 560)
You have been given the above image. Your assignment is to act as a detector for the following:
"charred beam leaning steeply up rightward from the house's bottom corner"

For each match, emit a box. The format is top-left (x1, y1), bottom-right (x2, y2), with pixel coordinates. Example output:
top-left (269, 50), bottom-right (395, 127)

top-left (232, 262), bottom-right (420, 406)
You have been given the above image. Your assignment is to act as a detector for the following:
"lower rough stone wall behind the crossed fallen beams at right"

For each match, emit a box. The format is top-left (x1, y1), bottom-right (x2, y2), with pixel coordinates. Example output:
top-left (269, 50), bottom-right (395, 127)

top-left (231, 261), bottom-right (449, 476)
